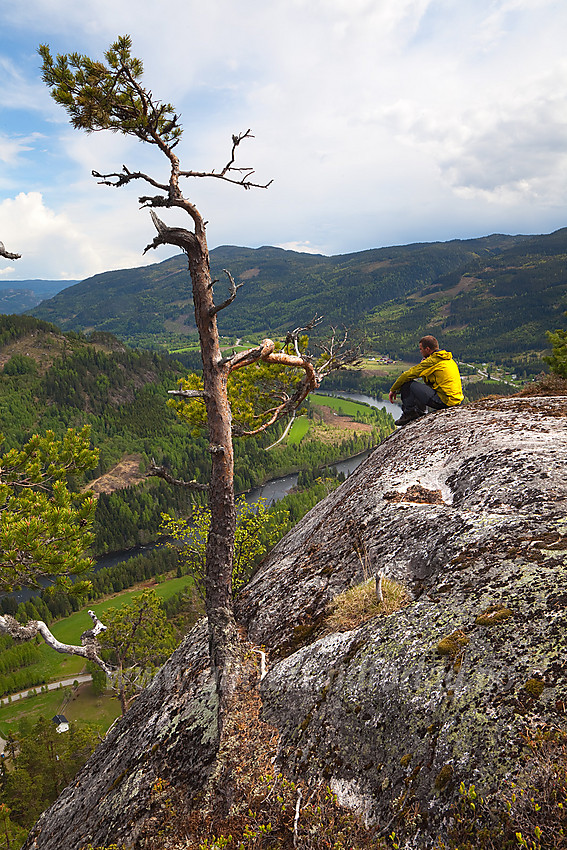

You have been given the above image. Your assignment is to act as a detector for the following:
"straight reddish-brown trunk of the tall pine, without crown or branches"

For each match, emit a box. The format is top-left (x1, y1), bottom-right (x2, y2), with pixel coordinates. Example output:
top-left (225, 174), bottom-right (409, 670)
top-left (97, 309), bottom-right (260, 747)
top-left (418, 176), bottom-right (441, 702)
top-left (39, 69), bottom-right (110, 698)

top-left (187, 229), bottom-right (237, 712)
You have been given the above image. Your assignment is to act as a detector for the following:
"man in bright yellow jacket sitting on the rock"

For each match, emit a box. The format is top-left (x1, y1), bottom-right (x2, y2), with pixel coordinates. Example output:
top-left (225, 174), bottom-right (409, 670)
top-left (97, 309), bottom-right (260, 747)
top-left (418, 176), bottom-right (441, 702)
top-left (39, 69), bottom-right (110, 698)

top-left (388, 336), bottom-right (463, 426)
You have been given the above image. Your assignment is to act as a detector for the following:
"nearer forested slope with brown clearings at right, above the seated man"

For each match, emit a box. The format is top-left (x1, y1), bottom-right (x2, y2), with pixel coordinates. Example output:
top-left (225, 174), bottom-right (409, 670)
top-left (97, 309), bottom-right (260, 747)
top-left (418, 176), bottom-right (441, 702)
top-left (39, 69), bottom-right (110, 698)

top-left (365, 229), bottom-right (567, 362)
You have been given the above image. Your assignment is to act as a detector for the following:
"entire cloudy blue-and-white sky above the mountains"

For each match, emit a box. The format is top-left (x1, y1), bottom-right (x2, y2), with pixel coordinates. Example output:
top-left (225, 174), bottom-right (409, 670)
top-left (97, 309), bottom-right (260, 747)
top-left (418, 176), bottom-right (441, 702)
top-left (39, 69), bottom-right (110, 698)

top-left (0, 0), bottom-right (567, 282)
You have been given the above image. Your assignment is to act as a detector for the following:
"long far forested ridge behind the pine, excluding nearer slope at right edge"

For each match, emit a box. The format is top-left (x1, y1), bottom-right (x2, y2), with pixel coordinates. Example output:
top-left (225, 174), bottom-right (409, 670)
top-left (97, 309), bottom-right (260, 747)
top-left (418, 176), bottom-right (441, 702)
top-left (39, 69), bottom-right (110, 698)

top-left (32, 230), bottom-right (540, 347)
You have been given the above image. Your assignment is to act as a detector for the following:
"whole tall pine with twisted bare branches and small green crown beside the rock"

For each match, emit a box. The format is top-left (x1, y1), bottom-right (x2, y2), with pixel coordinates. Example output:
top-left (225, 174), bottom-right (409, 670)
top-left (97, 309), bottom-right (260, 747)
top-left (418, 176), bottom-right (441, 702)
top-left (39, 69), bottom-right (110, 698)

top-left (39, 36), bottom-right (356, 731)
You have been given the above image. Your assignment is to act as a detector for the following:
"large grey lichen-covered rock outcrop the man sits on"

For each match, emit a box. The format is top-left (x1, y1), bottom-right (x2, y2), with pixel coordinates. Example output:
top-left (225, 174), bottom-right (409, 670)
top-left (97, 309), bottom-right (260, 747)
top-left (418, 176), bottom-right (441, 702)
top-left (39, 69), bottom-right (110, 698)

top-left (25, 397), bottom-right (567, 850)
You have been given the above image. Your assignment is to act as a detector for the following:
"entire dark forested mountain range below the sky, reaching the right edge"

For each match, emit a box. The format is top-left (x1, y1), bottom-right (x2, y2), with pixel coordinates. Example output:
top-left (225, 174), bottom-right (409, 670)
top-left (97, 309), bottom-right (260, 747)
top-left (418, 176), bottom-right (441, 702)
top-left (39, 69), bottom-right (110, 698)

top-left (29, 228), bottom-right (567, 360)
